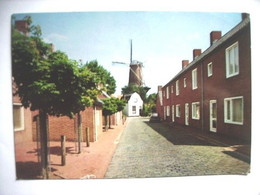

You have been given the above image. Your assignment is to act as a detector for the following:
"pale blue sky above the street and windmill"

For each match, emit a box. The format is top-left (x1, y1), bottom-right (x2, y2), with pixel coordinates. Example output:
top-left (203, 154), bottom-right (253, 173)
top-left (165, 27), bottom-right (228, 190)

top-left (14, 12), bottom-right (241, 95)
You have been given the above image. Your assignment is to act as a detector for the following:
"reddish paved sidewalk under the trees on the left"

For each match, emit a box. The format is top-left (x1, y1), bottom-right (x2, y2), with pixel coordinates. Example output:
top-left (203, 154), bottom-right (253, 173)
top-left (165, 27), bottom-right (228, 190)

top-left (16, 121), bottom-right (127, 179)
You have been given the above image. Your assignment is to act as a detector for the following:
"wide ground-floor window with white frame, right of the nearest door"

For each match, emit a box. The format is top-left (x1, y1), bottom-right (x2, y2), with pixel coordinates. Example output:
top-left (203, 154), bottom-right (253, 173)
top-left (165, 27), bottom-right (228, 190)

top-left (224, 96), bottom-right (244, 125)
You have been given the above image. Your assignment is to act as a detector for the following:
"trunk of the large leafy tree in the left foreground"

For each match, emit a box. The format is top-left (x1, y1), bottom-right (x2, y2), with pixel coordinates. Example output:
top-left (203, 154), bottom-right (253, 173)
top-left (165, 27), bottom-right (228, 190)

top-left (39, 110), bottom-right (49, 179)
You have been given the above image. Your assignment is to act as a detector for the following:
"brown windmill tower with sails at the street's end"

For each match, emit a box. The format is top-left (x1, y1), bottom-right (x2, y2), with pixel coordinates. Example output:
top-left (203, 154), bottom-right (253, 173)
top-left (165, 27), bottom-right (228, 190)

top-left (112, 40), bottom-right (144, 86)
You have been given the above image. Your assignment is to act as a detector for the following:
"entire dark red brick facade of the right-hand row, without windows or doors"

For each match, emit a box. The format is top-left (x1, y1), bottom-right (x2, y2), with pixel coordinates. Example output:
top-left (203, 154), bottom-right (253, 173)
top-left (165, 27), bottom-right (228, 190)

top-left (157, 17), bottom-right (251, 141)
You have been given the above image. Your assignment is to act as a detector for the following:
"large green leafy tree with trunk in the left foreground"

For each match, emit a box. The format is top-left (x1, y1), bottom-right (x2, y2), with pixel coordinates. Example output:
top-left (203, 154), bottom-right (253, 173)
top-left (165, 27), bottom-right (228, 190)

top-left (12, 17), bottom-right (98, 178)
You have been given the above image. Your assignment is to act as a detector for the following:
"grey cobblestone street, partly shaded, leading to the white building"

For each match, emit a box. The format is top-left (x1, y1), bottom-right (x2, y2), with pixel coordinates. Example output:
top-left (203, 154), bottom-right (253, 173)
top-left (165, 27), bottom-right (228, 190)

top-left (105, 117), bottom-right (250, 178)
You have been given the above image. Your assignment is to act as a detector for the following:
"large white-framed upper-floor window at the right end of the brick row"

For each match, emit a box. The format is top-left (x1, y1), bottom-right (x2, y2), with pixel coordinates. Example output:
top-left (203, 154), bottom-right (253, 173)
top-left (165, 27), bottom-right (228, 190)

top-left (226, 42), bottom-right (239, 78)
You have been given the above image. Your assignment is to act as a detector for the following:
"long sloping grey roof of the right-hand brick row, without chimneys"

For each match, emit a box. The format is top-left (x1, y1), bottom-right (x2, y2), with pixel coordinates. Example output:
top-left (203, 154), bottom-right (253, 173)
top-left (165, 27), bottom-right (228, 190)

top-left (163, 17), bottom-right (250, 87)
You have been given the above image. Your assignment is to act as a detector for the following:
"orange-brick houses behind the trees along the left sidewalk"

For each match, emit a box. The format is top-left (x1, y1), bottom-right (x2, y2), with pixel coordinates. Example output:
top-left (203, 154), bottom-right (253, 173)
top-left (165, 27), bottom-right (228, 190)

top-left (12, 20), bottom-right (123, 144)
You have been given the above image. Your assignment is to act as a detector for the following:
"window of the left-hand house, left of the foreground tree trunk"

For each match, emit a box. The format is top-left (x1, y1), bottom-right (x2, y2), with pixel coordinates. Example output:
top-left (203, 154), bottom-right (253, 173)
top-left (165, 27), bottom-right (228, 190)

top-left (13, 103), bottom-right (24, 131)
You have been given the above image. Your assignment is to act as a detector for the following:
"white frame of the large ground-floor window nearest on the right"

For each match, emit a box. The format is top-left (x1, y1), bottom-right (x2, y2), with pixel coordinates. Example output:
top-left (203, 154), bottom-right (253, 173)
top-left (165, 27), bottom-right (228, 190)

top-left (224, 96), bottom-right (244, 125)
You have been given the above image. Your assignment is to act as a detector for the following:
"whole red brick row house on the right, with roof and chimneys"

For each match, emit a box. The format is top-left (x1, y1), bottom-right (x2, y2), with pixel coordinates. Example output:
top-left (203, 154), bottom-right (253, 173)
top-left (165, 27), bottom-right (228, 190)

top-left (157, 14), bottom-right (251, 141)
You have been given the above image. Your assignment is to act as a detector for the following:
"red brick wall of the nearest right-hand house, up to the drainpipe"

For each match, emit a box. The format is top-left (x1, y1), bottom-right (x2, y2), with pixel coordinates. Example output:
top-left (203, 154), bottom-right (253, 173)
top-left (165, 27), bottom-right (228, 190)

top-left (203, 23), bottom-right (251, 140)
